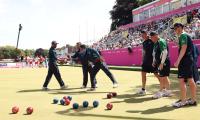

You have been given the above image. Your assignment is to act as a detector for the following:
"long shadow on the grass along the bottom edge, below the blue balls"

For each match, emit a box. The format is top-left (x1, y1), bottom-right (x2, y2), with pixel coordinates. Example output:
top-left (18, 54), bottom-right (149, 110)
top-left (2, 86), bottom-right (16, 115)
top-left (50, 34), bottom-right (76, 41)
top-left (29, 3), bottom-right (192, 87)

top-left (56, 107), bottom-right (170, 120)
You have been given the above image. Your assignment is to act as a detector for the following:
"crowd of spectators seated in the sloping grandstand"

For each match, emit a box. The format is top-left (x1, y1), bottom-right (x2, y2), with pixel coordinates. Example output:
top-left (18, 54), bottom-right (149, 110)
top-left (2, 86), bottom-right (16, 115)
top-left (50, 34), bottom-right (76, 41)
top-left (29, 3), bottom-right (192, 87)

top-left (92, 9), bottom-right (200, 50)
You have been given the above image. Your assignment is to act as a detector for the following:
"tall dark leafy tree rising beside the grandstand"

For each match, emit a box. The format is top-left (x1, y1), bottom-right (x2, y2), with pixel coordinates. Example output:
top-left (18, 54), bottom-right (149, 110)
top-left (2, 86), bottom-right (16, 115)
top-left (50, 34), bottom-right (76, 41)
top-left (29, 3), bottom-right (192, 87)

top-left (110, 0), bottom-right (155, 31)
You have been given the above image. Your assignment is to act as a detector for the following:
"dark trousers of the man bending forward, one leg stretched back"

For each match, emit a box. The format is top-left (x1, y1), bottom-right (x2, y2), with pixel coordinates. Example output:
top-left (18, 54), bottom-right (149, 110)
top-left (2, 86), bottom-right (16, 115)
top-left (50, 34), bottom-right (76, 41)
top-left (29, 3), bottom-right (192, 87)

top-left (90, 62), bottom-right (117, 88)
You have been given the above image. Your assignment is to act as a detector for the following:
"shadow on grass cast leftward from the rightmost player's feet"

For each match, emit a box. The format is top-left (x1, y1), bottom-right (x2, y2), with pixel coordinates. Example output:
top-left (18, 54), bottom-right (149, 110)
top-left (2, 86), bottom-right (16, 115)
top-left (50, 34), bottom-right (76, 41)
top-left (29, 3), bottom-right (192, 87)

top-left (126, 106), bottom-right (175, 114)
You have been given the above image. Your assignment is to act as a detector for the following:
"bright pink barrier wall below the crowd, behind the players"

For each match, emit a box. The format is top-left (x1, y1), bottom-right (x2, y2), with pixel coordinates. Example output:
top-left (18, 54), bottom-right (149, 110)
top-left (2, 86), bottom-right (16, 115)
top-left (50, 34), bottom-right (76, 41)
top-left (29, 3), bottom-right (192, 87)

top-left (101, 40), bottom-right (200, 67)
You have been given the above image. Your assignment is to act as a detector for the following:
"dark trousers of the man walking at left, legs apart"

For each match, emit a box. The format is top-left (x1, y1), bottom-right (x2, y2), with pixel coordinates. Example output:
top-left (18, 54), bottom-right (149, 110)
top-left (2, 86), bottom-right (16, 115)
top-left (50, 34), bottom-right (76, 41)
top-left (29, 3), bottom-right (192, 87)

top-left (43, 63), bottom-right (65, 87)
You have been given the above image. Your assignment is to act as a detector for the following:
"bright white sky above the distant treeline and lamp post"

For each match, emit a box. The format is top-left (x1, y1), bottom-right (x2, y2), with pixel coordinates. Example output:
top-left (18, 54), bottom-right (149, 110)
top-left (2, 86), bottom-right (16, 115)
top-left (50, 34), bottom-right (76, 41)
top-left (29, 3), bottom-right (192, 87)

top-left (0, 0), bottom-right (115, 49)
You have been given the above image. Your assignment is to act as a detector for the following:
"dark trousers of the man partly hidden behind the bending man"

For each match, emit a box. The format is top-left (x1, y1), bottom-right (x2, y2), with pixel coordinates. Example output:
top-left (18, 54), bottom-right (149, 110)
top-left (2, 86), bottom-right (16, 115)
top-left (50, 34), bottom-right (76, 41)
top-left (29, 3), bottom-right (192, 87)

top-left (82, 64), bottom-right (97, 86)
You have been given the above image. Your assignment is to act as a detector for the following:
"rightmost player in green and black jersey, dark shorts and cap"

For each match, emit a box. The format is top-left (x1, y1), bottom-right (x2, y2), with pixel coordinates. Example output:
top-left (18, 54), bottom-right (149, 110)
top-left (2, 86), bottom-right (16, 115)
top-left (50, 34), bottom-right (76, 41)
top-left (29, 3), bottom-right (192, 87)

top-left (172, 23), bottom-right (197, 108)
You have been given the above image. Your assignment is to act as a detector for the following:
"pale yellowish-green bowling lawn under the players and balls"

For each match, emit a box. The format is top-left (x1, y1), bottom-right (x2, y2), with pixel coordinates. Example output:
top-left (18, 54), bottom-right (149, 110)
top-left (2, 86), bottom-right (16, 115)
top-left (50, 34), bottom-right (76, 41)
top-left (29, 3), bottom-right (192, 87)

top-left (0, 66), bottom-right (200, 120)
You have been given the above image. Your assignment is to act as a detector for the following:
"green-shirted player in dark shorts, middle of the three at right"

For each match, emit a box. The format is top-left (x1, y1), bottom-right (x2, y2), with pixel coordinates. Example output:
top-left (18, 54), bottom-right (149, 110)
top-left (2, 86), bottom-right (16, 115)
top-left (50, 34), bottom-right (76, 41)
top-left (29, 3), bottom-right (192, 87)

top-left (150, 31), bottom-right (171, 99)
